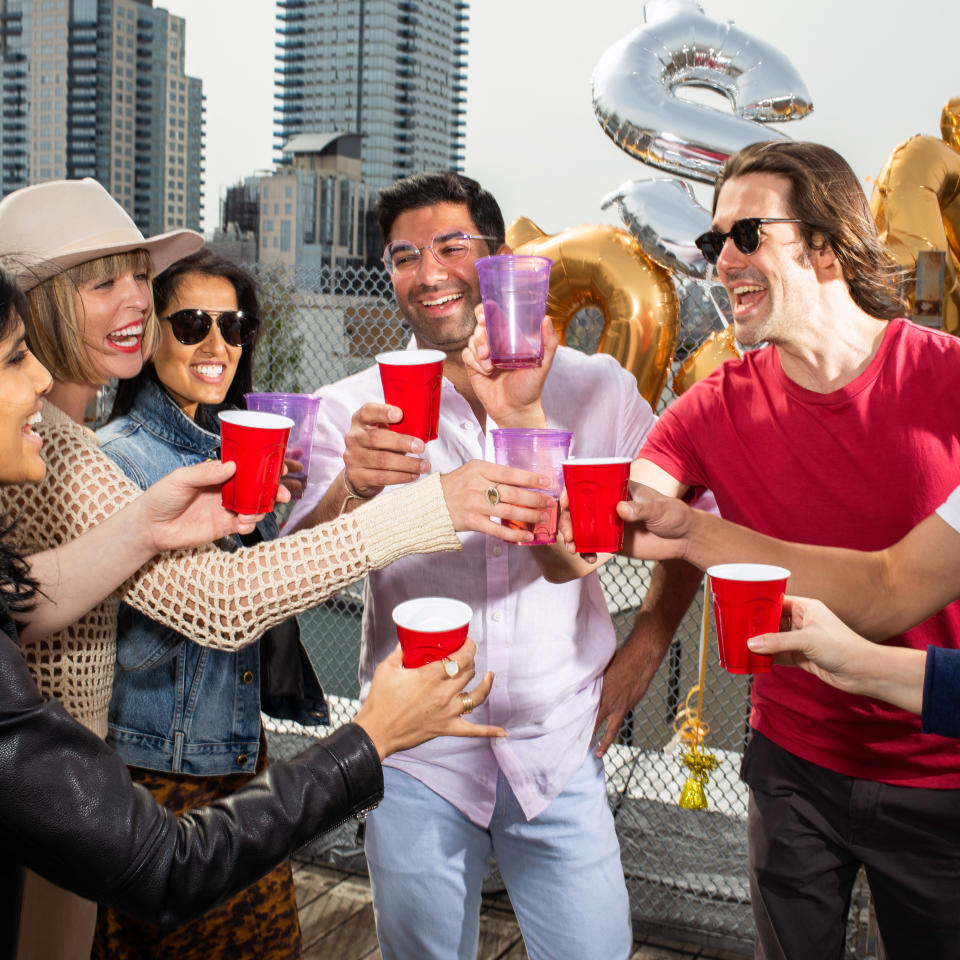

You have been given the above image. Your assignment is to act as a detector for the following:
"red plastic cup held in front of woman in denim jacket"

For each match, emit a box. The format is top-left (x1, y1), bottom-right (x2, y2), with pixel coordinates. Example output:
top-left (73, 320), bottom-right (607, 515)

top-left (217, 410), bottom-right (293, 513)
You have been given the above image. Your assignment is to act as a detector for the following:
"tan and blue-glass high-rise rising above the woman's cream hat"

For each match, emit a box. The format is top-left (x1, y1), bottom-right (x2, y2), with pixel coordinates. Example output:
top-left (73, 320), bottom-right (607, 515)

top-left (0, 0), bottom-right (204, 236)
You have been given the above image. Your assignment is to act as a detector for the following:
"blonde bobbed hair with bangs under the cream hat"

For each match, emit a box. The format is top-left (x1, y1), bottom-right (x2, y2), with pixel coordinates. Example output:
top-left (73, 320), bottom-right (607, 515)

top-left (23, 249), bottom-right (160, 386)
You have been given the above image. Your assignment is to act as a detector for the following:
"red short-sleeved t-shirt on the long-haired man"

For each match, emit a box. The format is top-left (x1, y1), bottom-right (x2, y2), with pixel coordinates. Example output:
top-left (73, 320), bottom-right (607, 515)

top-left (640, 320), bottom-right (960, 789)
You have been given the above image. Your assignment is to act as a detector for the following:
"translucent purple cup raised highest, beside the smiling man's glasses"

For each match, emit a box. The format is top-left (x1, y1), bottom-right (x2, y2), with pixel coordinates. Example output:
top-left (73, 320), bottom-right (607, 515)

top-left (477, 254), bottom-right (553, 370)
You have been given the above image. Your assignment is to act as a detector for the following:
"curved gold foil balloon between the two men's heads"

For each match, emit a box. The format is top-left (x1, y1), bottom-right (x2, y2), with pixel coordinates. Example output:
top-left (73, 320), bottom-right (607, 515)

top-left (507, 217), bottom-right (680, 407)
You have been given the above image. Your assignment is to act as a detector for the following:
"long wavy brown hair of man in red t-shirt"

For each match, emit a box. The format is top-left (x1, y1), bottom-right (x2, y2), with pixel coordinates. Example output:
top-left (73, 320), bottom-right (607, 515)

top-left (713, 140), bottom-right (907, 320)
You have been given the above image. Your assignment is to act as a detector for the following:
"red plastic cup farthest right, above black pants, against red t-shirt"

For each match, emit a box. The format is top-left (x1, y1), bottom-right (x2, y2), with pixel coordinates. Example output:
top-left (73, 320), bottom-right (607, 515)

top-left (707, 563), bottom-right (790, 673)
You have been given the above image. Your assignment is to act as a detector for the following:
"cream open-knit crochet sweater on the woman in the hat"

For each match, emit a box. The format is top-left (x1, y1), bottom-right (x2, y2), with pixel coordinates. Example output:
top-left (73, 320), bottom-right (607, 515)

top-left (0, 404), bottom-right (460, 735)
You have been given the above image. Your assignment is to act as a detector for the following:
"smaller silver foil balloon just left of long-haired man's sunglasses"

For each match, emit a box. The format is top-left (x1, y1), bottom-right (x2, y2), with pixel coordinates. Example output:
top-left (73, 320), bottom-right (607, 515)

top-left (600, 177), bottom-right (711, 280)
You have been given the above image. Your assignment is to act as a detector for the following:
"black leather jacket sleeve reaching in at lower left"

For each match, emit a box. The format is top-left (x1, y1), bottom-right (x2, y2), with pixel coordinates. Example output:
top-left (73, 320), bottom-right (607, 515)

top-left (0, 634), bottom-right (383, 936)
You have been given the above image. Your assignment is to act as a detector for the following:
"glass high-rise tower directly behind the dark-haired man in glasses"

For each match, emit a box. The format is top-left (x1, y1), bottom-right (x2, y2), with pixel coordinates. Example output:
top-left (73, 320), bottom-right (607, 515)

top-left (276, 0), bottom-right (469, 193)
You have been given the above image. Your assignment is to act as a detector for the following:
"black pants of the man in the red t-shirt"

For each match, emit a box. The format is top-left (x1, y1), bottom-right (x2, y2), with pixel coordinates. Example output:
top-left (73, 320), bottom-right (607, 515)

top-left (740, 733), bottom-right (960, 960)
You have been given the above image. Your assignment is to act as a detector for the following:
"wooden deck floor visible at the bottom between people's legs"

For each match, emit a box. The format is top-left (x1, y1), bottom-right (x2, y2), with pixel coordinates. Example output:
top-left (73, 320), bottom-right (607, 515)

top-left (294, 864), bottom-right (745, 960)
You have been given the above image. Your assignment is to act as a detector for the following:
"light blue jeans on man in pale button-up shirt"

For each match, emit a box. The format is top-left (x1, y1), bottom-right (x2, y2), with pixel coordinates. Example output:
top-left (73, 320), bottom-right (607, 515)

top-left (366, 752), bottom-right (633, 960)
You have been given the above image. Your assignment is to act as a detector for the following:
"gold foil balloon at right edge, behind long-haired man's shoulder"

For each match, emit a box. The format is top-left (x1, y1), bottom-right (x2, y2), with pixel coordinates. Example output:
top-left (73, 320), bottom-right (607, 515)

top-left (870, 98), bottom-right (960, 334)
